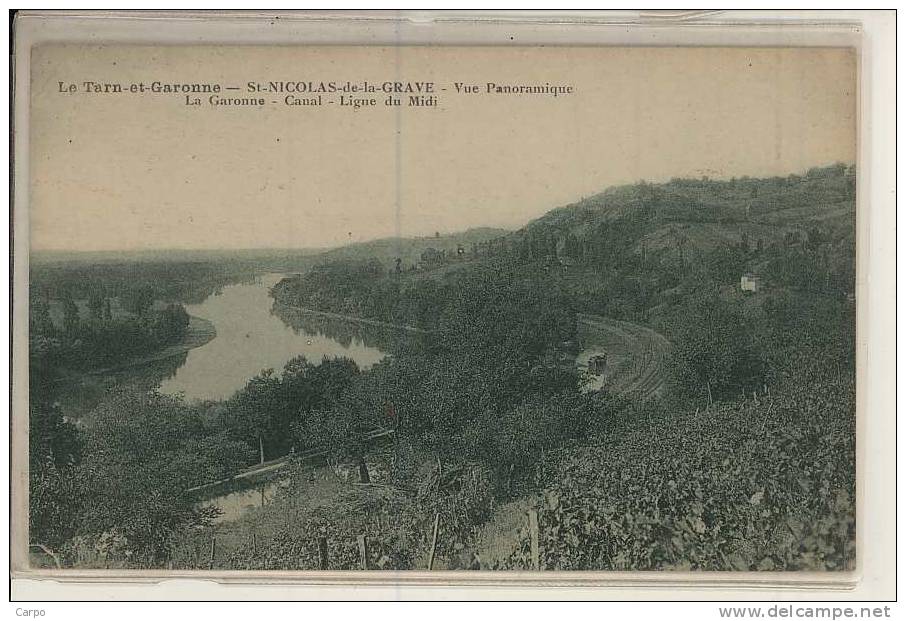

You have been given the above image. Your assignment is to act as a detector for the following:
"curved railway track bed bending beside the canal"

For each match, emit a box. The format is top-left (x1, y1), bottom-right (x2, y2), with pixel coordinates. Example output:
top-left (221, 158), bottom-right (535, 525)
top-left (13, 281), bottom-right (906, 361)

top-left (576, 314), bottom-right (670, 399)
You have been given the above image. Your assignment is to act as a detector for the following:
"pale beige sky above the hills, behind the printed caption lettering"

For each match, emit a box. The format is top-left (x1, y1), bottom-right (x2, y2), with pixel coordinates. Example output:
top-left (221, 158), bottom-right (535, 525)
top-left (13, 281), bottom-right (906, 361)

top-left (29, 46), bottom-right (856, 251)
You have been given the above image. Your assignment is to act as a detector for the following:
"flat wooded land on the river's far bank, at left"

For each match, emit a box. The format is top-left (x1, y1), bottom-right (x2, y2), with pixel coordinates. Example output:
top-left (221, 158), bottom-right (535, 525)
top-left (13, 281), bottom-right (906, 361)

top-left (29, 257), bottom-right (264, 400)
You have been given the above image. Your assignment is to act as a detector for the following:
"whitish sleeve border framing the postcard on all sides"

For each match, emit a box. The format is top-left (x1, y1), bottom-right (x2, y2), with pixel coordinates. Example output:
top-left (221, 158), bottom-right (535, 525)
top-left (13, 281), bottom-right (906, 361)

top-left (10, 11), bottom-right (896, 600)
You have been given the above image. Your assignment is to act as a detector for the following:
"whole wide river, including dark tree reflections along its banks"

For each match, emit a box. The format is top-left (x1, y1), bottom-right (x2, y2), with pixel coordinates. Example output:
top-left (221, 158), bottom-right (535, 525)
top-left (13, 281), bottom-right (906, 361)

top-left (46, 274), bottom-right (392, 419)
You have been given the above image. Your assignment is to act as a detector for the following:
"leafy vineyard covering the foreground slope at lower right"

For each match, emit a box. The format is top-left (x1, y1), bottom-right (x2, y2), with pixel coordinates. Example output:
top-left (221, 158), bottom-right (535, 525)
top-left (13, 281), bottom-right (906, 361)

top-left (502, 375), bottom-right (855, 571)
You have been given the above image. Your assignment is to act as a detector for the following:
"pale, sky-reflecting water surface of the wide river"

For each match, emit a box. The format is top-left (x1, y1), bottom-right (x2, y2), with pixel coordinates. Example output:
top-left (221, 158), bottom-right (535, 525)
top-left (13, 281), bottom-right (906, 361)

top-left (160, 274), bottom-right (385, 400)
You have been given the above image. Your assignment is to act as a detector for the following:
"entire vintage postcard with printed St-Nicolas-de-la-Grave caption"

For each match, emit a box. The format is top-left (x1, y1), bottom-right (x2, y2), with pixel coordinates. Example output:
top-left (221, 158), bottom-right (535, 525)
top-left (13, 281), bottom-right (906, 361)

top-left (15, 25), bottom-right (860, 576)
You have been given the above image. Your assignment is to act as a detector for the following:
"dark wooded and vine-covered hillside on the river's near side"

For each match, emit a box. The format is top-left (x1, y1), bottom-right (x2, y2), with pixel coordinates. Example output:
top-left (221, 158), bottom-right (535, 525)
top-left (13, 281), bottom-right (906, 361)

top-left (26, 166), bottom-right (855, 570)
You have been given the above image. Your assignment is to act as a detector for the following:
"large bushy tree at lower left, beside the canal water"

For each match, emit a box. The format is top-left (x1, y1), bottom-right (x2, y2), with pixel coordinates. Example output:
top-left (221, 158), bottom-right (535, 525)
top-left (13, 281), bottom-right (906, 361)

top-left (78, 390), bottom-right (233, 564)
